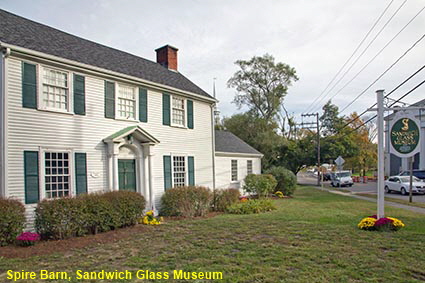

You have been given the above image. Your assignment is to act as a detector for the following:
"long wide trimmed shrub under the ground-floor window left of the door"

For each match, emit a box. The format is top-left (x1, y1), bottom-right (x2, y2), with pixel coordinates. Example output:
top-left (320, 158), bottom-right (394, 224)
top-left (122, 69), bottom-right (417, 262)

top-left (35, 191), bottom-right (145, 239)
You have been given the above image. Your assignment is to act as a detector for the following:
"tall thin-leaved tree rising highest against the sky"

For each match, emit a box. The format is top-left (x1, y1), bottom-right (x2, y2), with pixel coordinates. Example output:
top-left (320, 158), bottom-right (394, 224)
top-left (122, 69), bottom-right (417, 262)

top-left (227, 54), bottom-right (298, 122)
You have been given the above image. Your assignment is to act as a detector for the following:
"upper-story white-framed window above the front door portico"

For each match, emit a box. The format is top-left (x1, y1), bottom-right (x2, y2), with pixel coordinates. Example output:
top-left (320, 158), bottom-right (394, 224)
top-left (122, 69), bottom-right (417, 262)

top-left (116, 84), bottom-right (137, 120)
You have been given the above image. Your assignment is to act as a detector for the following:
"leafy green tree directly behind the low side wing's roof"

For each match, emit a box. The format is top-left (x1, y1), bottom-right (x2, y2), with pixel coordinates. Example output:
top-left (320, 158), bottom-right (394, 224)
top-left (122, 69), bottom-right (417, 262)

top-left (223, 112), bottom-right (284, 169)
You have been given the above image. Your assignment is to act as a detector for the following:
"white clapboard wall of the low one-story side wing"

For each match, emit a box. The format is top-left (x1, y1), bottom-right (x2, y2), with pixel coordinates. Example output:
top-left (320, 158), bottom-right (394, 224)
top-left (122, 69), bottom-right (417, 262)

top-left (215, 153), bottom-right (261, 192)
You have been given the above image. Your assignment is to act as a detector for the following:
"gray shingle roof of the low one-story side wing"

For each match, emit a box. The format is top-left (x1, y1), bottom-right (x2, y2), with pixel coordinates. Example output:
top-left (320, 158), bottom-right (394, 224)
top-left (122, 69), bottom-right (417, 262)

top-left (215, 130), bottom-right (261, 154)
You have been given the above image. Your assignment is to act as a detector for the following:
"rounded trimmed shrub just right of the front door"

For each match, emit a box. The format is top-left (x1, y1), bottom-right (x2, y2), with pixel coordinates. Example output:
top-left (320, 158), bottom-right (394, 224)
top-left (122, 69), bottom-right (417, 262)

top-left (161, 186), bottom-right (212, 217)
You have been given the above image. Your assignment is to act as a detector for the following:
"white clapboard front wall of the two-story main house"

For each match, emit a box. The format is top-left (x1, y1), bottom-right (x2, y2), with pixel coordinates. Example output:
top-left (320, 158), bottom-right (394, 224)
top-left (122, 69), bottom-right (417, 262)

top-left (6, 57), bottom-right (213, 223)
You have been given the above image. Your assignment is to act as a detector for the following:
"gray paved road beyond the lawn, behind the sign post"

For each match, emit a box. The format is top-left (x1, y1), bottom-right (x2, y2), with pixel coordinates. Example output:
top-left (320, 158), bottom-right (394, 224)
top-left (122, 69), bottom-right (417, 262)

top-left (297, 173), bottom-right (425, 202)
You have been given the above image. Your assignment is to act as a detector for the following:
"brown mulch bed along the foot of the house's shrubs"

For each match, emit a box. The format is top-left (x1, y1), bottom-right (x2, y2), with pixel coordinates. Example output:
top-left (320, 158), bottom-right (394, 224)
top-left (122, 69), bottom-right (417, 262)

top-left (0, 212), bottom-right (221, 258)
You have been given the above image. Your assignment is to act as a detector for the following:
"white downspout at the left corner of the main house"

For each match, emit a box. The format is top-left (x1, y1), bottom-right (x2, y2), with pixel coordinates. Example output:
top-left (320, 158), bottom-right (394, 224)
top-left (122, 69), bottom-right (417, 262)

top-left (0, 45), bottom-right (10, 197)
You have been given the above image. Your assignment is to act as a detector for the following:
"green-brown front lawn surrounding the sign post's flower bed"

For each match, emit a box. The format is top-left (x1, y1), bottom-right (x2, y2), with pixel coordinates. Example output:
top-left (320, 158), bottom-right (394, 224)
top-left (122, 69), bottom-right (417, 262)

top-left (0, 187), bottom-right (425, 283)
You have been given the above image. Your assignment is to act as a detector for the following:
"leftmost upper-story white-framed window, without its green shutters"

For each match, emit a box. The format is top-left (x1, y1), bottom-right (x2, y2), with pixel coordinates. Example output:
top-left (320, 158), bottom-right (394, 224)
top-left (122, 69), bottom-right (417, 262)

top-left (39, 66), bottom-right (71, 112)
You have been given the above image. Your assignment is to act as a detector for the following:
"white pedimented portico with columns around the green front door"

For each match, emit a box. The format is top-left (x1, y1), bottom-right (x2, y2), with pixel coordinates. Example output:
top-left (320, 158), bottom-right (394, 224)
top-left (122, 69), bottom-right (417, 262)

top-left (103, 126), bottom-right (159, 210)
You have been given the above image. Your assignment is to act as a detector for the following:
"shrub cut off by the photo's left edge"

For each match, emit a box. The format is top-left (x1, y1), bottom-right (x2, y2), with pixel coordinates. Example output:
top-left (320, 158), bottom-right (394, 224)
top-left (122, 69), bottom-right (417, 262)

top-left (0, 198), bottom-right (25, 246)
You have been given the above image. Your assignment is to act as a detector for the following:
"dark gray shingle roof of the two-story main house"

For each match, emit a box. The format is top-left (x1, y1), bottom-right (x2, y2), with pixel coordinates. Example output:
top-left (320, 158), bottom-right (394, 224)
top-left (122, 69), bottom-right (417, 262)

top-left (0, 9), bottom-right (211, 98)
